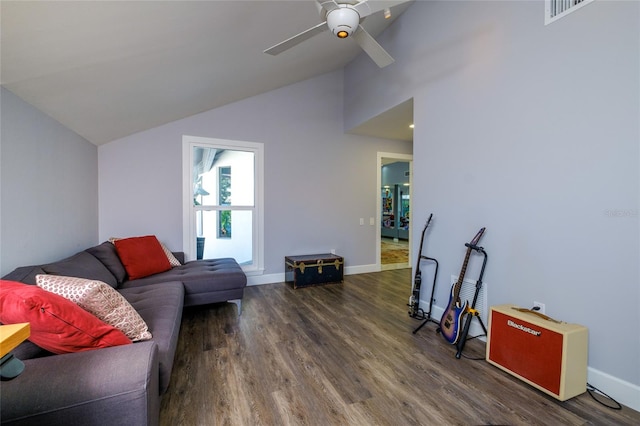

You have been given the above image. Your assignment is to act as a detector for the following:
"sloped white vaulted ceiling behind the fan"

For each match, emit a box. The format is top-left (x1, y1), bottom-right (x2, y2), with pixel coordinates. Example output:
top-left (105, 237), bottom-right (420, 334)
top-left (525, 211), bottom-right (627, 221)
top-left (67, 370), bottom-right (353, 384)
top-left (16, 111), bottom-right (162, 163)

top-left (0, 0), bottom-right (412, 145)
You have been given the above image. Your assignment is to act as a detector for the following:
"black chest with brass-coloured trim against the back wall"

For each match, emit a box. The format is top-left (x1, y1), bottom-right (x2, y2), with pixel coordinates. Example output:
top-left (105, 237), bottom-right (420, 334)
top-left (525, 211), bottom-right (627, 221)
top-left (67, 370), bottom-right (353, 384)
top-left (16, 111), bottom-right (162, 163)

top-left (284, 253), bottom-right (344, 288)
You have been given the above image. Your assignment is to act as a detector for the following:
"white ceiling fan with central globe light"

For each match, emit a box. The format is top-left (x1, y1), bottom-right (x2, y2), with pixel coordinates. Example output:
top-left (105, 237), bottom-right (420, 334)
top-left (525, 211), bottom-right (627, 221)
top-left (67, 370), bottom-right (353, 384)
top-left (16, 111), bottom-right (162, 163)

top-left (264, 0), bottom-right (404, 68)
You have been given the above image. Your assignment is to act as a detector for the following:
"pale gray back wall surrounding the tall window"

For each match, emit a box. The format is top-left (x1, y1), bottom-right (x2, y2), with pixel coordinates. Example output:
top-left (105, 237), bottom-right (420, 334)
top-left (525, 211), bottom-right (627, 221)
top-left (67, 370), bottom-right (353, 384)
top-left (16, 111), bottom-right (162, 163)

top-left (98, 71), bottom-right (411, 274)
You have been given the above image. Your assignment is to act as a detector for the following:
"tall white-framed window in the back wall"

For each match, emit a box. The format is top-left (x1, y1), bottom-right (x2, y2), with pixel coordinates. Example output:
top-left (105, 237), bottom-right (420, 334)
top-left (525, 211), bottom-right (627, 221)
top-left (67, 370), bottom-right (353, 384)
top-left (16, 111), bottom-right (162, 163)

top-left (183, 136), bottom-right (264, 273)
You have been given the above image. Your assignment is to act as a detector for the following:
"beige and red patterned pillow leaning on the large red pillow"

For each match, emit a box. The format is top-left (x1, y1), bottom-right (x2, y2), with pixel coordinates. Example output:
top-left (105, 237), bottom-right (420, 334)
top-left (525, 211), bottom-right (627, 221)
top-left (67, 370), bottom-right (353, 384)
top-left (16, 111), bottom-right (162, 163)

top-left (36, 275), bottom-right (151, 342)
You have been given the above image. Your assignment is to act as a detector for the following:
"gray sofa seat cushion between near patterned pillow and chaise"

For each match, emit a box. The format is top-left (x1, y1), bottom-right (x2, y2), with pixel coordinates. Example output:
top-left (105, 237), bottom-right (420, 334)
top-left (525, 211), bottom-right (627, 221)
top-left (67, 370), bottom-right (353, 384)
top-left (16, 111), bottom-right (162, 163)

top-left (119, 282), bottom-right (184, 393)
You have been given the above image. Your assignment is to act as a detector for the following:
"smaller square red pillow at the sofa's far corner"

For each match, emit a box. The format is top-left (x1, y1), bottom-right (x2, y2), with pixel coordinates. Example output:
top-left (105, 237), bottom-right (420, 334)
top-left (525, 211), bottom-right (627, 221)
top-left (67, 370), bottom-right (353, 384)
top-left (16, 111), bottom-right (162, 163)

top-left (113, 235), bottom-right (171, 280)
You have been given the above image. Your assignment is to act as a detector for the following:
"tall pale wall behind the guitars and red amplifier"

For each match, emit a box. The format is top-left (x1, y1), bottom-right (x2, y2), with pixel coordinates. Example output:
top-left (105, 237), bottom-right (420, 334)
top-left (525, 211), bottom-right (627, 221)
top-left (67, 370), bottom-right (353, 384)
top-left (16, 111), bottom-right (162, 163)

top-left (345, 1), bottom-right (640, 409)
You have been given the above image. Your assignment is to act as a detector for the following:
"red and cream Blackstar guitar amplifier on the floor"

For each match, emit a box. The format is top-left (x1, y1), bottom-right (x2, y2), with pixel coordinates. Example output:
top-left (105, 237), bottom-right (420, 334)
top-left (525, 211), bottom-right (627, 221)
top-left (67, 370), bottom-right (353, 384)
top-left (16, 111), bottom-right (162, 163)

top-left (487, 305), bottom-right (588, 401)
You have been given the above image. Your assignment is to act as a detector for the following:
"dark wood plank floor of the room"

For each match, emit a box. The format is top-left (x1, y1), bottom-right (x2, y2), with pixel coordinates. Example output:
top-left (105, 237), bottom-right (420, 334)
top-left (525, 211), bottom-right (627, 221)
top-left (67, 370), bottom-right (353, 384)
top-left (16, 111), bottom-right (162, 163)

top-left (160, 269), bottom-right (640, 426)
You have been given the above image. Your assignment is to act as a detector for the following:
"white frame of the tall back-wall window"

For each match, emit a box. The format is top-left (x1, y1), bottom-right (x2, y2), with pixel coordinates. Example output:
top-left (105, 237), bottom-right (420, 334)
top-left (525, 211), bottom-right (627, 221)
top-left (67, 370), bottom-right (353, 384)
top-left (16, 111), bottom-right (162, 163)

top-left (182, 135), bottom-right (264, 275)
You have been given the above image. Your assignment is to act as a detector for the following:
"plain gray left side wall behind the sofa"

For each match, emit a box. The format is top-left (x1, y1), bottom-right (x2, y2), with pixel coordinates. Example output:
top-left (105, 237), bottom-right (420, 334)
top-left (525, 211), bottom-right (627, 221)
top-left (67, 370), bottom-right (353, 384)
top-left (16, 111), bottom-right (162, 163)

top-left (0, 88), bottom-right (98, 275)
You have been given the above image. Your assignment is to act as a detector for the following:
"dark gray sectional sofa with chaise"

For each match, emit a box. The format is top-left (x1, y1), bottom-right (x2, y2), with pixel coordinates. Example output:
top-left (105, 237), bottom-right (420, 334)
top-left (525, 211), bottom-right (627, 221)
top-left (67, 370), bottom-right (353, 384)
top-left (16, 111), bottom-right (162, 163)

top-left (0, 242), bottom-right (247, 425)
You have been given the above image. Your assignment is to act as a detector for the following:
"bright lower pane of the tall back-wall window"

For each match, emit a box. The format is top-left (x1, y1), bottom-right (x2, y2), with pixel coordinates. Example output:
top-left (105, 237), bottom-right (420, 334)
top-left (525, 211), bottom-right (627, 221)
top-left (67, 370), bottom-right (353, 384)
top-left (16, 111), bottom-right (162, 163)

top-left (195, 210), bottom-right (253, 265)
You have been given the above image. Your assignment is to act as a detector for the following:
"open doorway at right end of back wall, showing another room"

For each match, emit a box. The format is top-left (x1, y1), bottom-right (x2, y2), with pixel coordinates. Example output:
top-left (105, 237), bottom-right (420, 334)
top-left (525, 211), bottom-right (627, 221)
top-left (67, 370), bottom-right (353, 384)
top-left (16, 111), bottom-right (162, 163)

top-left (377, 153), bottom-right (413, 270)
